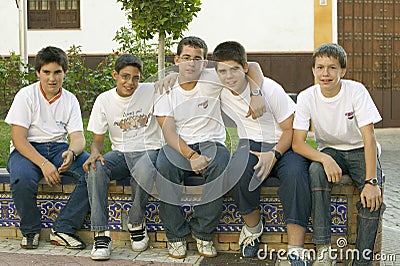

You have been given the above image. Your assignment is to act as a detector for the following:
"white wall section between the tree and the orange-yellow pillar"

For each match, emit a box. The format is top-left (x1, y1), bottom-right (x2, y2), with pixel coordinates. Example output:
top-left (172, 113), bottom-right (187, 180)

top-left (185, 0), bottom-right (314, 52)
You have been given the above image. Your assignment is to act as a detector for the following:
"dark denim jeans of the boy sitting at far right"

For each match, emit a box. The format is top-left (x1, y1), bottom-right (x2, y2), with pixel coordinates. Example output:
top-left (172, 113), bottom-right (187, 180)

top-left (310, 148), bottom-right (385, 265)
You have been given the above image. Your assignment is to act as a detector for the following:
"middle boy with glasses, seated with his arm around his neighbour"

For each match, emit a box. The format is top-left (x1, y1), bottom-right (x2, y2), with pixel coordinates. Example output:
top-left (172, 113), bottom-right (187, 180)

top-left (154, 36), bottom-right (262, 258)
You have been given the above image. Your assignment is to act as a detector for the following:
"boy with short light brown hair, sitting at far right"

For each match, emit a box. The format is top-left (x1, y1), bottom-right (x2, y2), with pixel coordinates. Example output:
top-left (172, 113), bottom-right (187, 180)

top-left (293, 43), bottom-right (384, 265)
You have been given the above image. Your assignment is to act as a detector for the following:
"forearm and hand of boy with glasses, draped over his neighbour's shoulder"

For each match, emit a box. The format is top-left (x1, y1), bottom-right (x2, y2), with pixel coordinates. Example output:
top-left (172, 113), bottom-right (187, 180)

top-left (246, 62), bottom-right (267, 119)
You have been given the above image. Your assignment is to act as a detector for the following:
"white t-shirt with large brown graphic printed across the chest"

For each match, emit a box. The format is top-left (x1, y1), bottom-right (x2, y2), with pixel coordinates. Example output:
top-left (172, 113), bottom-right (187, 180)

top-left (88, 83), bottom-right (163, 152)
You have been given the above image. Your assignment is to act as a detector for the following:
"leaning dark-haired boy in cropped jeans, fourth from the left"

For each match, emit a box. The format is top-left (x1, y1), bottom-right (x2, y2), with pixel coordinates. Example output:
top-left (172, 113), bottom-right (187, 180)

top-left (213, 41), bottom-right (311, 265)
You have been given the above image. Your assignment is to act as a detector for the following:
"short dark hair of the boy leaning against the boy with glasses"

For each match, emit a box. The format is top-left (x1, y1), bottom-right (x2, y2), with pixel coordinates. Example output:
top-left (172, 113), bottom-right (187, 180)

top-left (213, 41), bottom-right (247, 67)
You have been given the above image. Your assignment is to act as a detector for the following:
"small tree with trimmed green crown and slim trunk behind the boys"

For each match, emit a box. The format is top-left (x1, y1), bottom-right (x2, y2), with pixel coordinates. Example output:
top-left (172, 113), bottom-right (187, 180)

top-left (117, 0), bottom-right (201, 77)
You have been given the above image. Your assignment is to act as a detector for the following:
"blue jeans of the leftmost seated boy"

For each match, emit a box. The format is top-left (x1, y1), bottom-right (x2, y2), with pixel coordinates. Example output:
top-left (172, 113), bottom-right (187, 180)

top-left (7, 142), bottom-right (89, 235)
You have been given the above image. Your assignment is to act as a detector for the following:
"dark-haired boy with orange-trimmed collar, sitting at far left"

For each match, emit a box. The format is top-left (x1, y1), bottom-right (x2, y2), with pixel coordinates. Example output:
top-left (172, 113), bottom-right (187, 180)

top-left (5, 46), bottom-right (89, 249)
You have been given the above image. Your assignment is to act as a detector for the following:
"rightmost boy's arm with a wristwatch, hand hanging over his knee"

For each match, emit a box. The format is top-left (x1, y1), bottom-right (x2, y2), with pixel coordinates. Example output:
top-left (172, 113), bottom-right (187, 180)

top-left (360, 124), bottom-right (382, 212)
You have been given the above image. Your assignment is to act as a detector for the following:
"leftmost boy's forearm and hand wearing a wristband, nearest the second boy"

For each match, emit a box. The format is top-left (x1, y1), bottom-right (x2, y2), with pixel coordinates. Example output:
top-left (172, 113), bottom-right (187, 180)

top-left (58, 131), bottom-right (86, 173)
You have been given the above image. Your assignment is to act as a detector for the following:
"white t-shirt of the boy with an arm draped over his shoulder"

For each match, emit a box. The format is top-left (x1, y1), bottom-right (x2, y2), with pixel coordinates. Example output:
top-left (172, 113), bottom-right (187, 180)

top-left (221, 78), bottom-right (295, 143)
